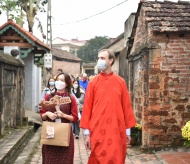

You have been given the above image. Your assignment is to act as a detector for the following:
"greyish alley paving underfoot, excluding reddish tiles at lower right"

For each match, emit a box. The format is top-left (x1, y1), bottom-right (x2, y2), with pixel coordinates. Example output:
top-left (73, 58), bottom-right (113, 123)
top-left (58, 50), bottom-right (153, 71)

top-left (20, 127), bottom-right (190, 164)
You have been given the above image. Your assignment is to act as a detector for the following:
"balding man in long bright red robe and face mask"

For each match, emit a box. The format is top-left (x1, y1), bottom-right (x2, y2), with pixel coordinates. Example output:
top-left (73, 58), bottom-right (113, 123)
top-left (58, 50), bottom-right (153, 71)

top-left (80, 49), bottom-right (136, 164)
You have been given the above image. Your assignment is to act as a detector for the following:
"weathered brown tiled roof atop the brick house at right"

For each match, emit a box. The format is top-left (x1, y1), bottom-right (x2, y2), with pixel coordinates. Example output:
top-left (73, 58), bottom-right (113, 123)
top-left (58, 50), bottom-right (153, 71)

top-left (141, 1), bottom-right (190, 32)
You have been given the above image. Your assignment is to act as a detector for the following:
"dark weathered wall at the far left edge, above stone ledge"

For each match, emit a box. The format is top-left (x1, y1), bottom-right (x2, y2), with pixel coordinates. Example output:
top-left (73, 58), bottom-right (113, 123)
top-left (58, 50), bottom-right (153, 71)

top-left (0, 54), bottom-right (25, 135)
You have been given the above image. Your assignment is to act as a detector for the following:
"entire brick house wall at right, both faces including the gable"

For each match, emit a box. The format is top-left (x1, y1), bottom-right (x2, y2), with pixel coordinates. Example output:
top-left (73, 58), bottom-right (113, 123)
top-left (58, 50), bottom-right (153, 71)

top-left (128, 5), bottom-right (190, 148)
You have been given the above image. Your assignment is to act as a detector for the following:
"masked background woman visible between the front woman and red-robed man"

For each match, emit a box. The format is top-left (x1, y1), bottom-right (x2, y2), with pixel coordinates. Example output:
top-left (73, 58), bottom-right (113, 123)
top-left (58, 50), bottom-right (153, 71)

top-left (71, 79), bottom-right (85, 139)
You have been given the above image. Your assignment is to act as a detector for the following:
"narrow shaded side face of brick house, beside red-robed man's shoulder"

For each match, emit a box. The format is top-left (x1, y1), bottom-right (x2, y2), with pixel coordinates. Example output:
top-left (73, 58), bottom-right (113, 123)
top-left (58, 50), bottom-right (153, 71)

top-left (128, 51), bottom-right (149, 125)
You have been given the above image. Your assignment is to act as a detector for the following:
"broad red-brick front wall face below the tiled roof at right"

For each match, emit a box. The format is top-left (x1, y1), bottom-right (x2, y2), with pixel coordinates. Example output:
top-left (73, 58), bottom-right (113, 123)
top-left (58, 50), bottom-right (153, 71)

top-left (144, 33), bottom-right (190, 147)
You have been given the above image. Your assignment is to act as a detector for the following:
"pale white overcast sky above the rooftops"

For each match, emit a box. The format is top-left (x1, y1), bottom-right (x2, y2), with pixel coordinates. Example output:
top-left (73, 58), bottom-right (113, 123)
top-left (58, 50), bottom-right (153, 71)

top-left (0, 0), bottom-right (140, 40)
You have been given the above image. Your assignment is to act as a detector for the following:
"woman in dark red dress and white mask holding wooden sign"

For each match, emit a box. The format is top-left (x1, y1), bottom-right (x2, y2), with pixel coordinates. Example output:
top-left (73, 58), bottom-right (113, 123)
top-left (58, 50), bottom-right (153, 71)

top-left (40, 73), bottom-right (78, 164)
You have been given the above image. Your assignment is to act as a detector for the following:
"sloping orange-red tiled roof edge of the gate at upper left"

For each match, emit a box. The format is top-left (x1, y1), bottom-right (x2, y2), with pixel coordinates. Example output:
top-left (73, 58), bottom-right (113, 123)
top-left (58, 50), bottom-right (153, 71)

top-left (0, 19), bottom-right (50, 50)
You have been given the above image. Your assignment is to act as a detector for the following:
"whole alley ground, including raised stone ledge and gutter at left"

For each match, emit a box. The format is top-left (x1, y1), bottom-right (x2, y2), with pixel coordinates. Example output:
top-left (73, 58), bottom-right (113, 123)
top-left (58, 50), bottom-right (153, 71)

top-left (0, 121), bottom-right (190, 164)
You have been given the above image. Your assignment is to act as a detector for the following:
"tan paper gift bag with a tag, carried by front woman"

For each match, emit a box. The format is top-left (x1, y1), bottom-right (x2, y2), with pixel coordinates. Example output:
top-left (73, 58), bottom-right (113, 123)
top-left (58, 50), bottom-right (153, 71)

top-left (40, 121), bottom-right (71, 146)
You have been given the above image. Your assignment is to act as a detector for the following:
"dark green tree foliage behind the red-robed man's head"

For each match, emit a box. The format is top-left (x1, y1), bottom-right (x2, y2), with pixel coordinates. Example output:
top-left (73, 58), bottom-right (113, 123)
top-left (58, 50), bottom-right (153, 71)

top-left (77, 36), bottom-right (109, 62)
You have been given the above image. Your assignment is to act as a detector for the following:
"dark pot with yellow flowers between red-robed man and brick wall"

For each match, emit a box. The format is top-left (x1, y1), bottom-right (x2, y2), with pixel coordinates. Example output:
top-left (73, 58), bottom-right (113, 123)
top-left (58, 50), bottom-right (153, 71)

top-left (130, 123), bottom-right (142, 146)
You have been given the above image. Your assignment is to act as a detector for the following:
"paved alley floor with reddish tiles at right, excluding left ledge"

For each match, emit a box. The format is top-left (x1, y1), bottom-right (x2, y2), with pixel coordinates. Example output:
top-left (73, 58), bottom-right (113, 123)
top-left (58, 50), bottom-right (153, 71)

top-left (29, 129), bottom-right (190, 164)
